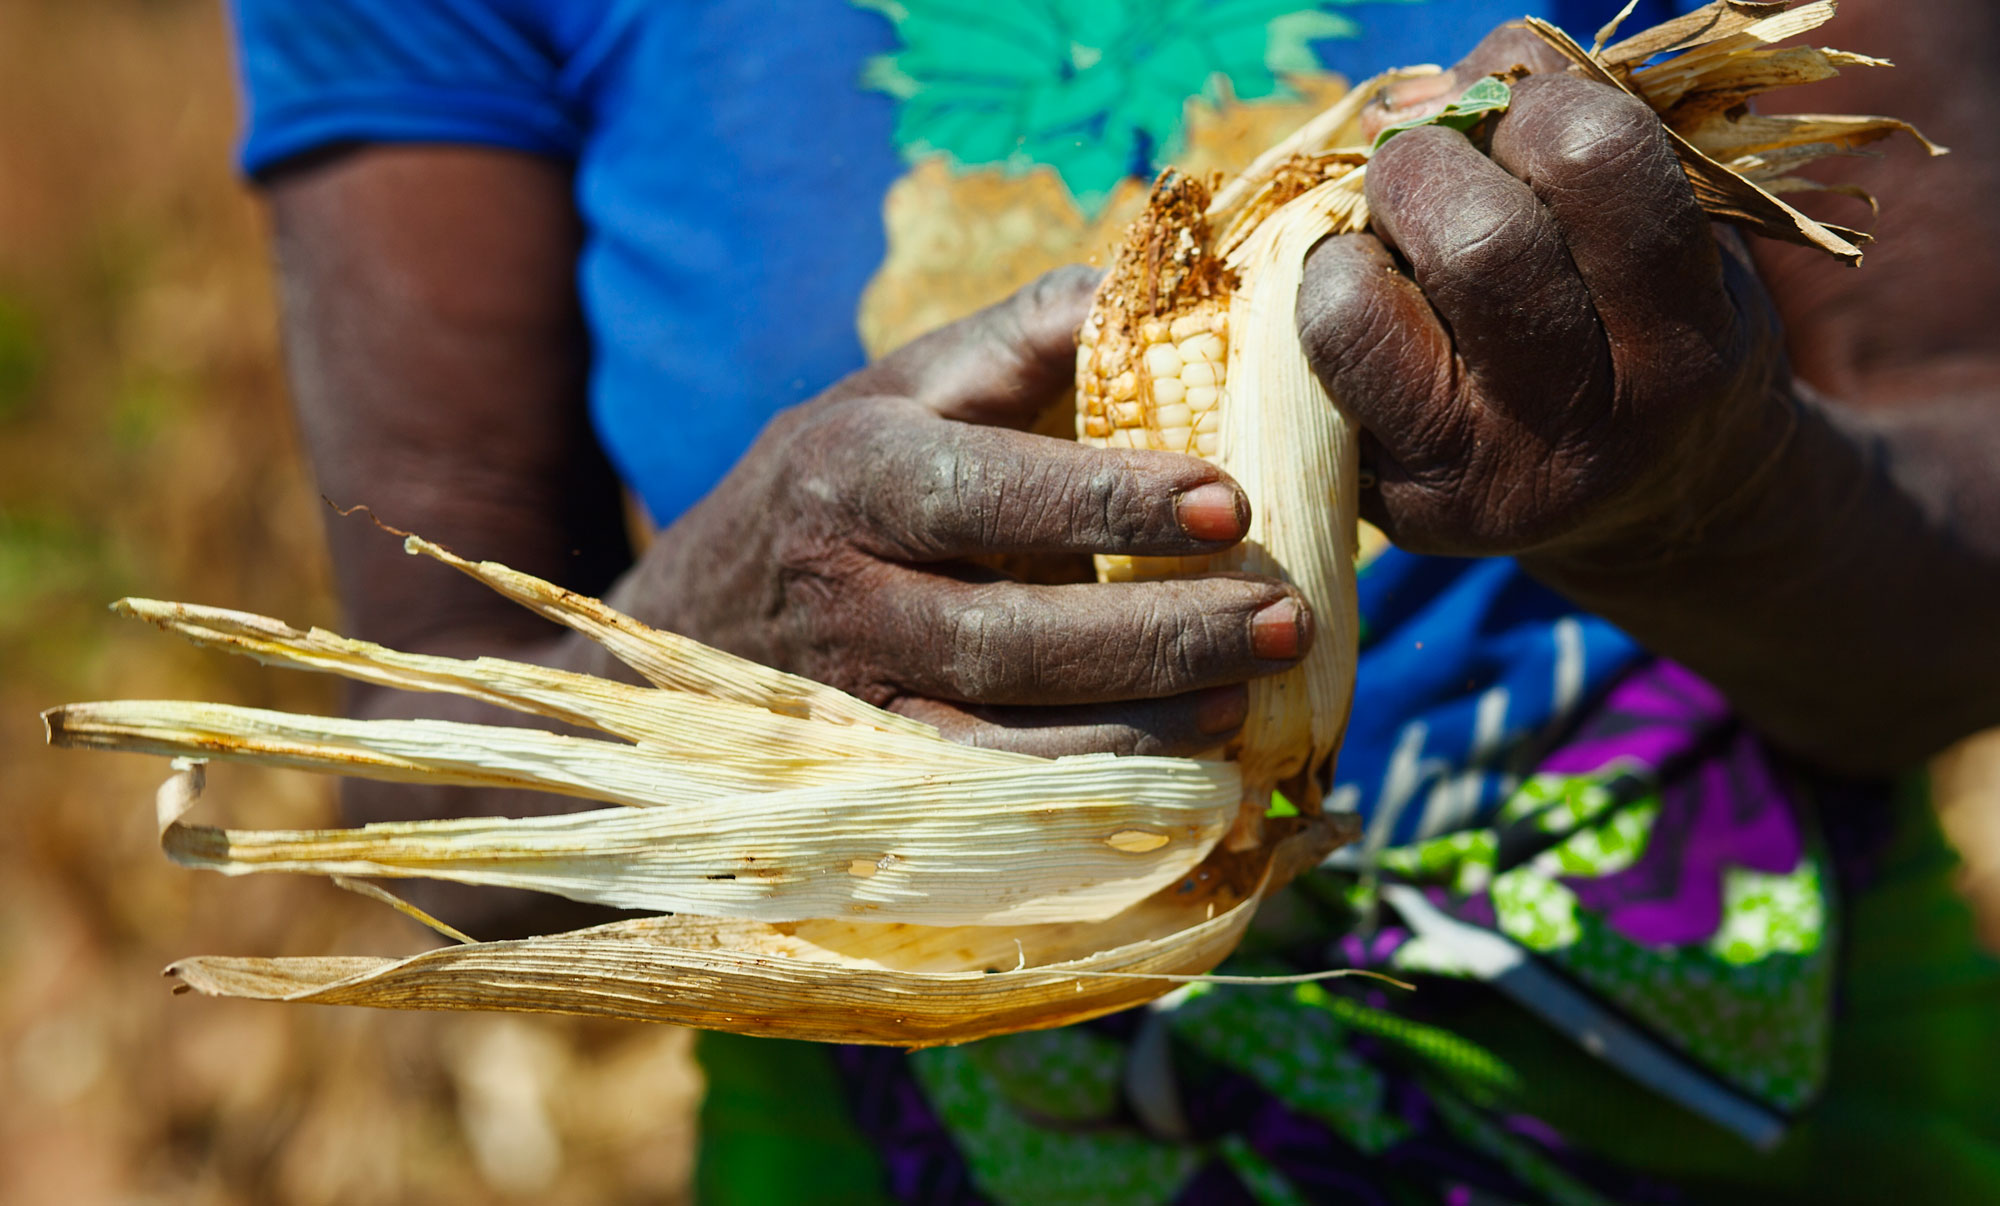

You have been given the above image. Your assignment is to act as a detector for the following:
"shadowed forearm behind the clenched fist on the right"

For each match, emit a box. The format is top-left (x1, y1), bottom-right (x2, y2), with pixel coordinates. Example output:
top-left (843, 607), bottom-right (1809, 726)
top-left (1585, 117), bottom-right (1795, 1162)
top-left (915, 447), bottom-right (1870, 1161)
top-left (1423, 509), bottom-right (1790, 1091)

top-left (1522, 382), bottom-right (2000, 774)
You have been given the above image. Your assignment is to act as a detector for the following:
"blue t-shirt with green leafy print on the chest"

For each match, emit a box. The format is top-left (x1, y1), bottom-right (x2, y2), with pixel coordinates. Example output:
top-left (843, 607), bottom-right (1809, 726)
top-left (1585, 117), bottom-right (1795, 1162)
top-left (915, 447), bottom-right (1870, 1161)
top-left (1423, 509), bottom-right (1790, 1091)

top-left (234, 0), bottom-right (1666, 840)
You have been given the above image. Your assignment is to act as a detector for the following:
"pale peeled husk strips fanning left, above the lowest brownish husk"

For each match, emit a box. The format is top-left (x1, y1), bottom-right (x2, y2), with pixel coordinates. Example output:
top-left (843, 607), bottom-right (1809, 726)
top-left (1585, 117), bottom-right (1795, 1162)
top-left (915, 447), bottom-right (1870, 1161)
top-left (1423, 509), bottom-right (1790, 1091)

top-left (44, 540), bottom-right (1240, 924)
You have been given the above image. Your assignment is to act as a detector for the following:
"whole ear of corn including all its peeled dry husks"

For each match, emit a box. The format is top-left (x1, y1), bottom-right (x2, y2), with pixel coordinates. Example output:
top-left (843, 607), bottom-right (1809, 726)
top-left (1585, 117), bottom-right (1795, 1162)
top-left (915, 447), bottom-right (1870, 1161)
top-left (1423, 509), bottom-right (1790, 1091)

top-left (44, 0), bottom-right (1938, 1046)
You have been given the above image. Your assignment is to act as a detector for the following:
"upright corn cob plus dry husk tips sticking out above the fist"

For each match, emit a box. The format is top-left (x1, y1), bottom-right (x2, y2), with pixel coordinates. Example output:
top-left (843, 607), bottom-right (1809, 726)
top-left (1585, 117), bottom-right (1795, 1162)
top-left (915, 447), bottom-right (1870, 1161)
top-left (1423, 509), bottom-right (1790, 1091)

top-left (1076, 0), bottom-right (1938, 844)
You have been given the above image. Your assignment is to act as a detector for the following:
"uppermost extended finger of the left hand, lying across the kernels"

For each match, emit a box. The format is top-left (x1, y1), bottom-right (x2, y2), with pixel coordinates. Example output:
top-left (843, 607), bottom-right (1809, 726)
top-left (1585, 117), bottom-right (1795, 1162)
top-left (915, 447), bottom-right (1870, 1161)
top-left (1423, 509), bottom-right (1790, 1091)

top-left (846, 402), bottom-right (1250, 562)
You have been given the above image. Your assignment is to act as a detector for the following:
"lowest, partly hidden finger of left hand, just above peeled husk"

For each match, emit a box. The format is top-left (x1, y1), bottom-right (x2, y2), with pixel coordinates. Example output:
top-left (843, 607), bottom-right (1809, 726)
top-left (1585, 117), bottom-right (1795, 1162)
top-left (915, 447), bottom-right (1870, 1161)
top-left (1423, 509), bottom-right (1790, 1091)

top-left (890, 686), bottom-right (1250, 758)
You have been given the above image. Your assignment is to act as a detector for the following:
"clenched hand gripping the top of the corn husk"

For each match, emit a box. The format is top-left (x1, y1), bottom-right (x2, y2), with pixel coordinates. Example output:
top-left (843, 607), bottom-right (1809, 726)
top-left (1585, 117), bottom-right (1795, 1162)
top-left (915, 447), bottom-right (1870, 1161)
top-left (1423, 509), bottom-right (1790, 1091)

top-left (1298, 28), bottom-right (1790, 560)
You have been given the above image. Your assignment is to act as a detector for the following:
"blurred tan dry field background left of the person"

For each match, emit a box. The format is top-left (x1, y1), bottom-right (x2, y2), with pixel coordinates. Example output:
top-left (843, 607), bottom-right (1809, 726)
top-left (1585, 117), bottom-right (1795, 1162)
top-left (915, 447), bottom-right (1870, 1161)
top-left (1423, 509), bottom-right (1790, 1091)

top-left (0, 0), bottom-right (700, 1204)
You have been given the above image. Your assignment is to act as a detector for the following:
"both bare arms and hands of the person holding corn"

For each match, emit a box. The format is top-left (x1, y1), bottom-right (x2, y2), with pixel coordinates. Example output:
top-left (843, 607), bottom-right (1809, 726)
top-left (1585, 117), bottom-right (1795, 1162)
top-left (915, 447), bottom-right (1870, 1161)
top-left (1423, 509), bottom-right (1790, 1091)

top-left (268, 0), bottom-right (2000, 928)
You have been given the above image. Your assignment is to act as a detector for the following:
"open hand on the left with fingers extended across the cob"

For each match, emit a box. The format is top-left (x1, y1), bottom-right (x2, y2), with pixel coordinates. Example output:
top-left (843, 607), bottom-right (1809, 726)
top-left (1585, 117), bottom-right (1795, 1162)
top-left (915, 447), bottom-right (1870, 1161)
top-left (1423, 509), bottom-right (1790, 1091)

top-left (616, 270), bottom-right (1312, 756)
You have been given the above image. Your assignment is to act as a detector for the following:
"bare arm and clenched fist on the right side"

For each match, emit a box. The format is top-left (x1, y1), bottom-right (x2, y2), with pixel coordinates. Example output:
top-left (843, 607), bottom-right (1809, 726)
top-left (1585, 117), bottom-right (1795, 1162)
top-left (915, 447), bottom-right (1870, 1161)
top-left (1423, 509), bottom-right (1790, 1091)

top-left (1300, 14), bottom-right (2000, 774)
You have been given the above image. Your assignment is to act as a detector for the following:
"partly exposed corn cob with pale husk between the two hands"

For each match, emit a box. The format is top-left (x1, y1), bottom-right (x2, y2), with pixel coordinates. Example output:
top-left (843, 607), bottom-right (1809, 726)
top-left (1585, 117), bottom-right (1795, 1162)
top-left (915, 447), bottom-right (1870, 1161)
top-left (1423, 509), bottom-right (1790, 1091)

top-left (1076, 120), bottom-right (1366, 820)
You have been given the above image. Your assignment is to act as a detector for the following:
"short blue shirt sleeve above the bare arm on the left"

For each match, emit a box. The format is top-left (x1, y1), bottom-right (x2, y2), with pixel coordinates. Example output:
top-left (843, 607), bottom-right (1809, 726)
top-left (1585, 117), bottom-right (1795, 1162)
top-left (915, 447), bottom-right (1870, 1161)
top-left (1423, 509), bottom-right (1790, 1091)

top-left (230, 0), bottom-right (582, 174)
